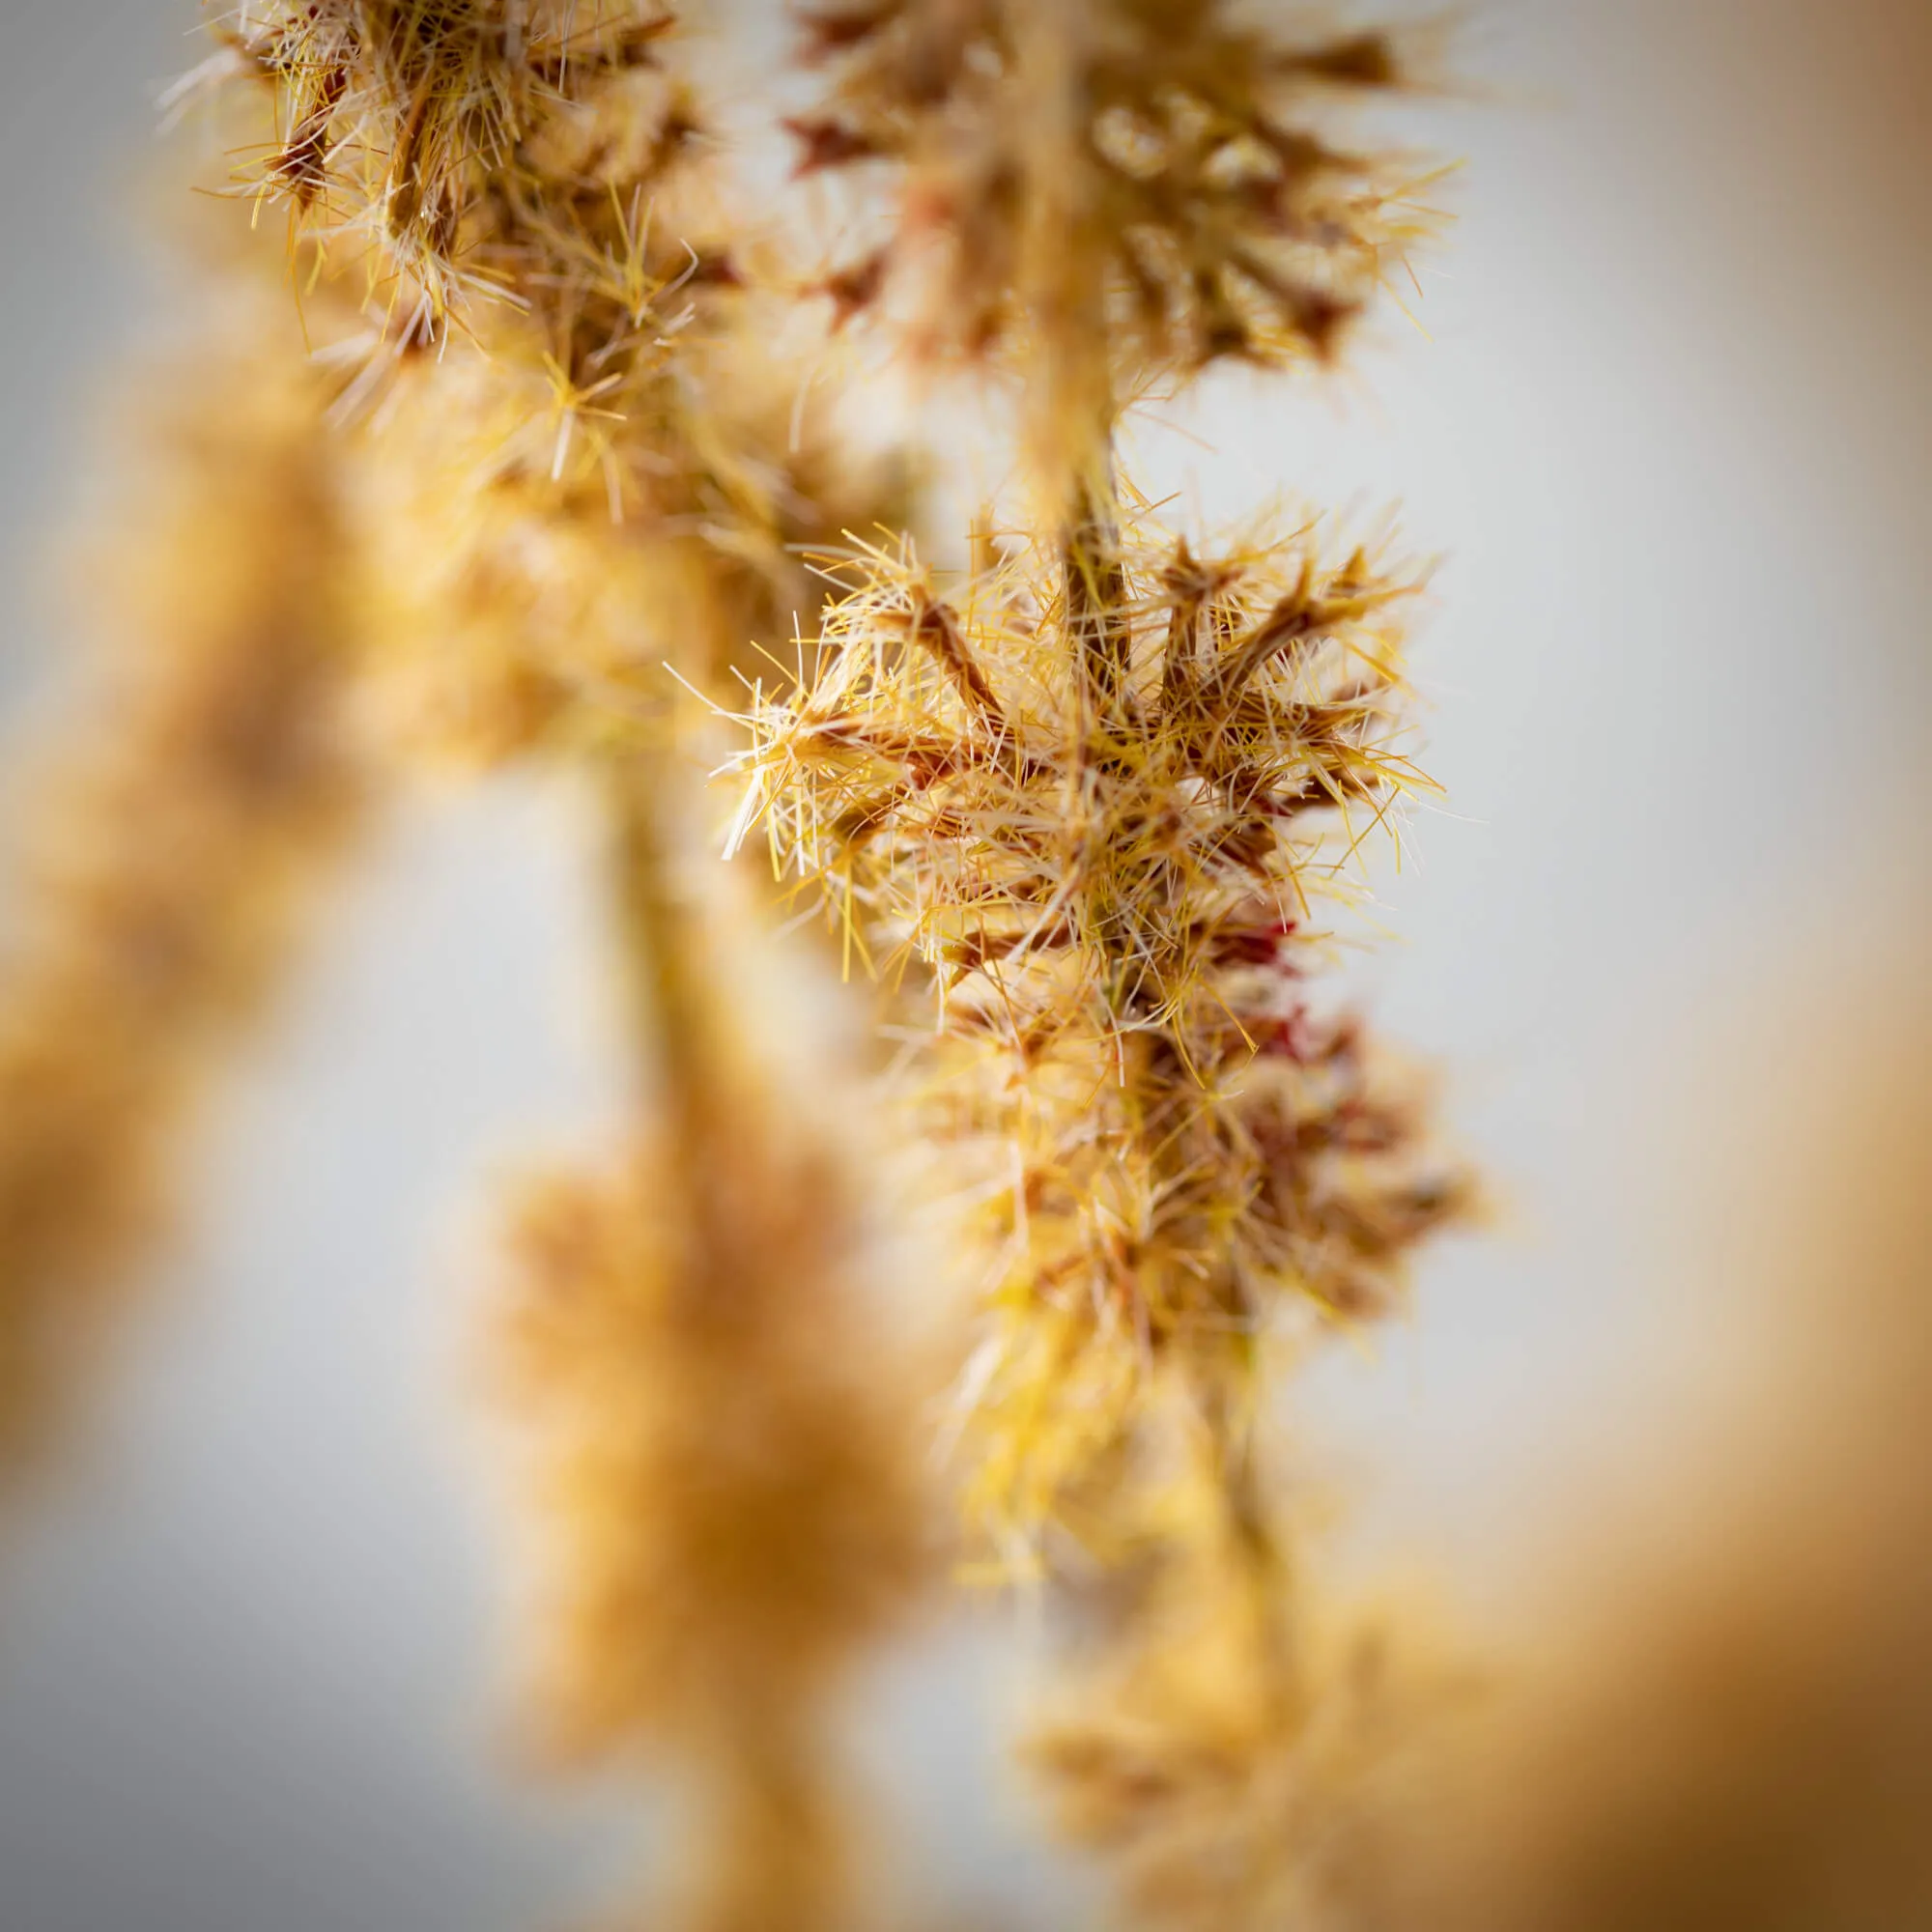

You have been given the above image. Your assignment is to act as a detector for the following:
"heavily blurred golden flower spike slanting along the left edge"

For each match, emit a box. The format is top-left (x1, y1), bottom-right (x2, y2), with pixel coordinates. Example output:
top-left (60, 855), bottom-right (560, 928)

top-left (0, 309), bottom-right (371, 1480)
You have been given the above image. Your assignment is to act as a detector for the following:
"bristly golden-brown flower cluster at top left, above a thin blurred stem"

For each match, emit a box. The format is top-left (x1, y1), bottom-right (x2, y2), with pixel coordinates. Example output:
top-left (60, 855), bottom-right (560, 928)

top-left (200, 4), bottom-right (908, 777)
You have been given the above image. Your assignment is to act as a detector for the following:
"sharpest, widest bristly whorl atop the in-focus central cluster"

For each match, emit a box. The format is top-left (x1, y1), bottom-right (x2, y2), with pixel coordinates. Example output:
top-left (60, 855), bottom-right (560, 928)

top-left (748, 506), bottom-right (1428, 1055)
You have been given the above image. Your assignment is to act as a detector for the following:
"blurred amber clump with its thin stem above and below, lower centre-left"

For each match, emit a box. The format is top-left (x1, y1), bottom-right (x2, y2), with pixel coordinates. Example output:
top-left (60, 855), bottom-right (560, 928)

top-left (495, 746), bottom-right (923, 1932)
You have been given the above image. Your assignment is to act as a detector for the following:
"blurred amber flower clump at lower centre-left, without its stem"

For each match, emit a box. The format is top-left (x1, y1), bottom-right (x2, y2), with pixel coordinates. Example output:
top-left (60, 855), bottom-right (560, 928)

top-left (506, 1122), bottom-right (922, 1756)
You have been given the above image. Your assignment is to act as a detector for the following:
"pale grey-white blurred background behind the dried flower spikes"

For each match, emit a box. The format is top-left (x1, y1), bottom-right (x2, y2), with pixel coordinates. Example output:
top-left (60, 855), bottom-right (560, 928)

top-left (0, 0), bottom-right (1932, 1932)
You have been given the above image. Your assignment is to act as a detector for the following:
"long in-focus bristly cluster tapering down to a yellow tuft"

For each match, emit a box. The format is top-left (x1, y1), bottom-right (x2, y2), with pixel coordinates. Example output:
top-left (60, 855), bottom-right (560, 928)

top-left (748, 506), bottom-right (1459, 1532)
